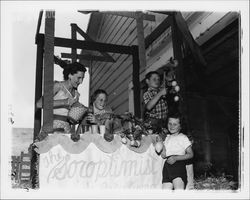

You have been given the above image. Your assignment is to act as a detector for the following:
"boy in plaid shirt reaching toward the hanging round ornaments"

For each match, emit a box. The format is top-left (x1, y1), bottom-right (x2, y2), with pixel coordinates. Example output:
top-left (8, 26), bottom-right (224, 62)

top-left (143, 71), bottom-right (168, 139)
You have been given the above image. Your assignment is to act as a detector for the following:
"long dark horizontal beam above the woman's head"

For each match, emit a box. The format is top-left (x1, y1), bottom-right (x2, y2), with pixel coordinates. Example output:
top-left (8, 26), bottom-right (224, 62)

top-left (38, 34), bottom-right (132, 54)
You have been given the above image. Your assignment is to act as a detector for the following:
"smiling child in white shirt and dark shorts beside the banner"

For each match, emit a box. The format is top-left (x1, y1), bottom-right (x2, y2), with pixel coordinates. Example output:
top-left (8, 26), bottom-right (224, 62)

top-left (161, 113), bottom-right (193, 190)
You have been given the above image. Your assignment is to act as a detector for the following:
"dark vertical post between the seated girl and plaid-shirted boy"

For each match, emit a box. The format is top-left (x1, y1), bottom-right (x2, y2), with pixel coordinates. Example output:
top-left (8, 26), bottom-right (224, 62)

top-left (132, 46), bottom-right (141, 118)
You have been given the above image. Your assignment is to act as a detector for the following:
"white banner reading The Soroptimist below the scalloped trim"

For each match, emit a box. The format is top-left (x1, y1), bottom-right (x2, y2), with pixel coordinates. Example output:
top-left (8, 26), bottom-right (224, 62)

top-left (39, 143), bottom-right (163, 189)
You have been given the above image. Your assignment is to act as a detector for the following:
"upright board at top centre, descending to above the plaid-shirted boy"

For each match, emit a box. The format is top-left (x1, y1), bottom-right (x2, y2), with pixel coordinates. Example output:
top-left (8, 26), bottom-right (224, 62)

top-left (136, 12), bottom-right (147, 71)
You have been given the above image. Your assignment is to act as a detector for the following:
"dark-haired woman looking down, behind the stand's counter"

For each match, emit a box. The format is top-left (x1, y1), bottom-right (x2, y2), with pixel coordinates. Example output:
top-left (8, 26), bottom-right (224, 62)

top-left (37, 57), bottom-right (86, 139)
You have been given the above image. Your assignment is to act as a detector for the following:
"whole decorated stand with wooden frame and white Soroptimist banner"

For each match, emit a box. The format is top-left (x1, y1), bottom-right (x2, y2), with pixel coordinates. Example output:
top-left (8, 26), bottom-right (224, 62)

top-left (31, 11), bottom-right (207, 189)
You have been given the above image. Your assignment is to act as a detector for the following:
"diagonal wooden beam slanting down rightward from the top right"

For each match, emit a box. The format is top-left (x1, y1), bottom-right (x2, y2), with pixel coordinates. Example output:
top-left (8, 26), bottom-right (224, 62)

top-left (174, 12), bottom-right (206, 66)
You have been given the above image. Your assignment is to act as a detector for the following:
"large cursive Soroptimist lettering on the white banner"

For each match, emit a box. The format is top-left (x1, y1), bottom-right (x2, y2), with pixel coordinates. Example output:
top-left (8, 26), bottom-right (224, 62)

top-left (46, 154), bottom-right (157, 183)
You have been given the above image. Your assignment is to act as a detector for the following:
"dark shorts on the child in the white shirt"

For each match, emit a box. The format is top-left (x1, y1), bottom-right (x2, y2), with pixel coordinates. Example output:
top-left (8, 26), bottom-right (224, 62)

top-left (162, 160), bottom-right (187, 187)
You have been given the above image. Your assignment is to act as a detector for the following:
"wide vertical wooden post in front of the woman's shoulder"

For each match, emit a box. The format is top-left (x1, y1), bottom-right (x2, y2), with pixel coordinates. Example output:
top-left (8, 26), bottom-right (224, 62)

top-left (43, 11), bottom-right (55, 132)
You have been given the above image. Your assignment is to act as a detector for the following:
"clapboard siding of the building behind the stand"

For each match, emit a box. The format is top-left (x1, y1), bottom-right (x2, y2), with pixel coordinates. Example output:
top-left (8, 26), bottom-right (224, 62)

top-left (90, 15), bottom-right (167, 112)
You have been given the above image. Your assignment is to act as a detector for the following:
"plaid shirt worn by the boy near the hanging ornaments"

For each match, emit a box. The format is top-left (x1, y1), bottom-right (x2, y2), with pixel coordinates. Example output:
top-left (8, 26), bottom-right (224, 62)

top-left (143, 88), bottom-right (168, 119)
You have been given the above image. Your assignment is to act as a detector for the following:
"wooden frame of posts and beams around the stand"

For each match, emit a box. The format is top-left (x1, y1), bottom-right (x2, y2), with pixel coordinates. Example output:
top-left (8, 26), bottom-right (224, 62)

top-left (31, 11), bottom-right (205, 188)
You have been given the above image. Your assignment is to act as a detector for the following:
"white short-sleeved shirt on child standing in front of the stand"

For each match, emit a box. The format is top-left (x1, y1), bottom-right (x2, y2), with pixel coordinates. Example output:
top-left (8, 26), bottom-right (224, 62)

top-left (164, 133), bottom-right (191, 156)
